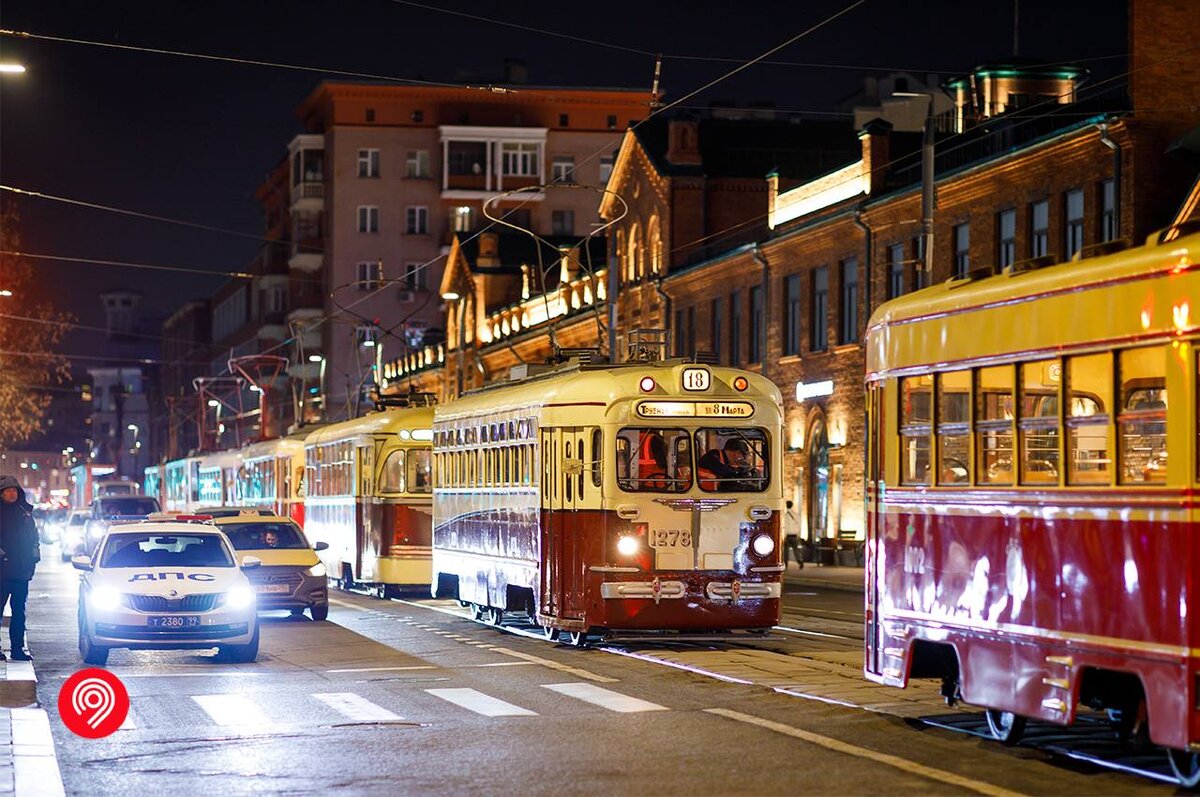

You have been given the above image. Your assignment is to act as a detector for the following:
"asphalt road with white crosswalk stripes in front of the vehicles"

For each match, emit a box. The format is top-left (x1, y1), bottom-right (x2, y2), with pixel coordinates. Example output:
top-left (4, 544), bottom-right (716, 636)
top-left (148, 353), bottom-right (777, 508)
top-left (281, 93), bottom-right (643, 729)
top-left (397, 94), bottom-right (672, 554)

top-left (29, 557), bottom-right (1172, 796)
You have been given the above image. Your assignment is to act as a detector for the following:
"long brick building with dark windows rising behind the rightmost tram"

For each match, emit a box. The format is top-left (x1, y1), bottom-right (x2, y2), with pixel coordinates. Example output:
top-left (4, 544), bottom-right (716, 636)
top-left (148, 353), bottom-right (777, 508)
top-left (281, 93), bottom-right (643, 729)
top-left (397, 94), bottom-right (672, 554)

top-left (652, 0), bottom-right (1200, 552)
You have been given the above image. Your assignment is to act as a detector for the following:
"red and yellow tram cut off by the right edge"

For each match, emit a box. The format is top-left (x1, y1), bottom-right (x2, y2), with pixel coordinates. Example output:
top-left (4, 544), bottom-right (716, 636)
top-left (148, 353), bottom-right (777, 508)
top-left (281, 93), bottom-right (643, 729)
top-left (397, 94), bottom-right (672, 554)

top-left (865, 226), bottom-right (1200, 785)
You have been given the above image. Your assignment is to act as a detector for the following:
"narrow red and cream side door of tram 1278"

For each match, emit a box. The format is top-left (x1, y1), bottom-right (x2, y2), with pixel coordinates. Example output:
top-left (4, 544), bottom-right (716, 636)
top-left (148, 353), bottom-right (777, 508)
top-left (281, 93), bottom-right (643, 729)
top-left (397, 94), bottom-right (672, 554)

top-left (540, 429), bottom-right (583, 619)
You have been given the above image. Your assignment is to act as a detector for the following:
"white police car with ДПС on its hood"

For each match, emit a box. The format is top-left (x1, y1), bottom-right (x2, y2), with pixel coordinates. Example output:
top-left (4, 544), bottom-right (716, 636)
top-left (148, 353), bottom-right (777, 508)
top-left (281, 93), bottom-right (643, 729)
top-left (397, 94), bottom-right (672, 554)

top-left (72, 519), bottom-right (260, 665)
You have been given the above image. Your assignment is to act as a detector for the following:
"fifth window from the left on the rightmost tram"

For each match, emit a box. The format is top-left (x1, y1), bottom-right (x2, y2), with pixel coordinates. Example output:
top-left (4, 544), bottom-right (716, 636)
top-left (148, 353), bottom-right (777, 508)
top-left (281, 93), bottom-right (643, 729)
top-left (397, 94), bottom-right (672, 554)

top-left (1067, 352), bottom-right (1112, 484)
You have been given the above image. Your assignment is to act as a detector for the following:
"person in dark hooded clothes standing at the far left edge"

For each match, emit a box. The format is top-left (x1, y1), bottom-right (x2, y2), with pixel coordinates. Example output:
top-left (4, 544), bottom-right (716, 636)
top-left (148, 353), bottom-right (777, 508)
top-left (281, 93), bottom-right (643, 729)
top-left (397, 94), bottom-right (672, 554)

top-left (0, 477), bottom-right (42, 661)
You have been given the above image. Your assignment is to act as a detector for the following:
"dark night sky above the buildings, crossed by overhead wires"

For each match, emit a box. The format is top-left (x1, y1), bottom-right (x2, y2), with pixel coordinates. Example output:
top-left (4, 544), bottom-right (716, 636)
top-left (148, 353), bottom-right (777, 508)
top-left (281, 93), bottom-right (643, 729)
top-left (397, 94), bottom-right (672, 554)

top-left (0, 0), bottom-right (1127, 353)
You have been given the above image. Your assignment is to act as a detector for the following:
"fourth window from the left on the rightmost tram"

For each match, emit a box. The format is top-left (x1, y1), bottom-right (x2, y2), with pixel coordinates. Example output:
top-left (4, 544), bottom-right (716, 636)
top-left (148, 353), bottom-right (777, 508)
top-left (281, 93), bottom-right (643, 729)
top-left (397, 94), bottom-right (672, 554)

top-left (1016, 360), bottom-right (1062, 484)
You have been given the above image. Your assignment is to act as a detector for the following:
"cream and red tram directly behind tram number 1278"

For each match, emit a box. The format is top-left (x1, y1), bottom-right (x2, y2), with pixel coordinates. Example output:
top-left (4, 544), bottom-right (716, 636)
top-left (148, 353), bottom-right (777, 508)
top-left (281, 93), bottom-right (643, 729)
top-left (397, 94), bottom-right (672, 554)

top-left (304, 397), bottom-right (433, 597)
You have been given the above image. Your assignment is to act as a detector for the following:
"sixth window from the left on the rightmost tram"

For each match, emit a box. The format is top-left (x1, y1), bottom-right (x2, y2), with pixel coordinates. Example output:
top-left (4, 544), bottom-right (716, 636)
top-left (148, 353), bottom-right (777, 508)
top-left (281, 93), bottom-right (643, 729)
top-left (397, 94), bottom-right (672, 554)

top-left (1117, 347), bottom-right (1166, 484)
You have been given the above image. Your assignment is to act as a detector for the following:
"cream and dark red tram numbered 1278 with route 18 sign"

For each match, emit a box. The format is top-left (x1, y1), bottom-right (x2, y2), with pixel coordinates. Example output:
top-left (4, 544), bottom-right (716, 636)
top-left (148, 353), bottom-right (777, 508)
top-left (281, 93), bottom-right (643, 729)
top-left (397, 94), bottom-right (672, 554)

top-left (433, 361), bottom-right (782, 645)
